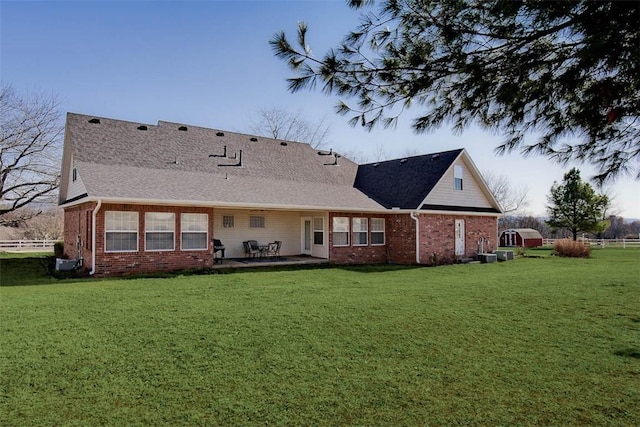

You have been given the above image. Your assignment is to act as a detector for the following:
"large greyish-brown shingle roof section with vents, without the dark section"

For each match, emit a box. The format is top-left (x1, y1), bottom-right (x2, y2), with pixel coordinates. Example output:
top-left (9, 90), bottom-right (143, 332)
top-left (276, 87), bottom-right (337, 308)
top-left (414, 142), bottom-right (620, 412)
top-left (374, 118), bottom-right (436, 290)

top-left (61, 113), bottom-right (382, 210)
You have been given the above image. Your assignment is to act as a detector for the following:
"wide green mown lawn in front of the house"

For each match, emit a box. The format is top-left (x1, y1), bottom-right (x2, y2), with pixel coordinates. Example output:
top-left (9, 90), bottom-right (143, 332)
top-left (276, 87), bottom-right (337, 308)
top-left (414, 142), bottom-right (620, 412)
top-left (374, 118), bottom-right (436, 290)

top-left (0, 248), bottom-right (640, 426)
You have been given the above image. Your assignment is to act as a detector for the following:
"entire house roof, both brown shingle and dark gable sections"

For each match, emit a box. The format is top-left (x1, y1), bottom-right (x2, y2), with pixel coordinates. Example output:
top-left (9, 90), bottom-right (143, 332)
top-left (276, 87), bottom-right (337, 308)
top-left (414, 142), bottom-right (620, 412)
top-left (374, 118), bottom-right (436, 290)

top-left (59, 113), bottom-right (499, 213)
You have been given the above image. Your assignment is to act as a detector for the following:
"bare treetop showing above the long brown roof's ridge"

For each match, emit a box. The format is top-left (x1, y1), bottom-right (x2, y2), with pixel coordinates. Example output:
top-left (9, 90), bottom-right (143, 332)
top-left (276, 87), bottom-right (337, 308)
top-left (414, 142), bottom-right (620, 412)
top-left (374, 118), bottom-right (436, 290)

top-left (250, 107), bottom-right (331, 149)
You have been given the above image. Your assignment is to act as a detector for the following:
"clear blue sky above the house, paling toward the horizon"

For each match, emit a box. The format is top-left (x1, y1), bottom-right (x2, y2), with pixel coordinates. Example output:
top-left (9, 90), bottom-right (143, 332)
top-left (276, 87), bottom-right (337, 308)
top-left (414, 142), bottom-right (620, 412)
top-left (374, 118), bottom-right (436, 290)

top-left (0, 0), bottom-right (640, 219)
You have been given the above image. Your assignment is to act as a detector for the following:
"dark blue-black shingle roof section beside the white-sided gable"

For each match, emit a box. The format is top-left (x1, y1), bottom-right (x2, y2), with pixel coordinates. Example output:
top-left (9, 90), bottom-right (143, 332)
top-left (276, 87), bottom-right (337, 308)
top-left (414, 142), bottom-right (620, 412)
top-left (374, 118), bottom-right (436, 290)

top-left (354, 149), bottom-right (462, 209)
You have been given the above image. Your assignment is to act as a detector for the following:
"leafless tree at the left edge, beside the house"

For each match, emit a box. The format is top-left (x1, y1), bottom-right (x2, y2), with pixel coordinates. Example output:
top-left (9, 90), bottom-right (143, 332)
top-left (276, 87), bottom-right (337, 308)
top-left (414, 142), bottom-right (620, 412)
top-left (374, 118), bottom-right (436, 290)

top-left (0, 84), bottom-right (64, 225)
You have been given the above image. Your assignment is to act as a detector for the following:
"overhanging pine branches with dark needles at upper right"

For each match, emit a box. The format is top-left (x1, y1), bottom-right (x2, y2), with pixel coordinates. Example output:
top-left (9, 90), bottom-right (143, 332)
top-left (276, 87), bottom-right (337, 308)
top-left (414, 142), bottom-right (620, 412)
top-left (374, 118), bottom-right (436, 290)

top-left (270, 0), bottom-right (640, 181)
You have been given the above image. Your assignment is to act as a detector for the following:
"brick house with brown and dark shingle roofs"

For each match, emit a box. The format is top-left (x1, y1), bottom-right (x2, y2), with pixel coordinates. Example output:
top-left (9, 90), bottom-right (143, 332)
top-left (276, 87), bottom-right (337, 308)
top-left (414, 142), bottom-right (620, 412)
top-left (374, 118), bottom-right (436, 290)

top-left (59, 113), bottom-right (501, 275)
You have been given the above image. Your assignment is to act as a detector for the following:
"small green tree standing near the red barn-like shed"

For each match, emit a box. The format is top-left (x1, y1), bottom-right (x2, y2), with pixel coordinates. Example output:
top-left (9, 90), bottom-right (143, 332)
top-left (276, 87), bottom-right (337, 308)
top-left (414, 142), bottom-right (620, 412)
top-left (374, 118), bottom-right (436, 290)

top-left (546, 168), bottom-right (609, 240)
